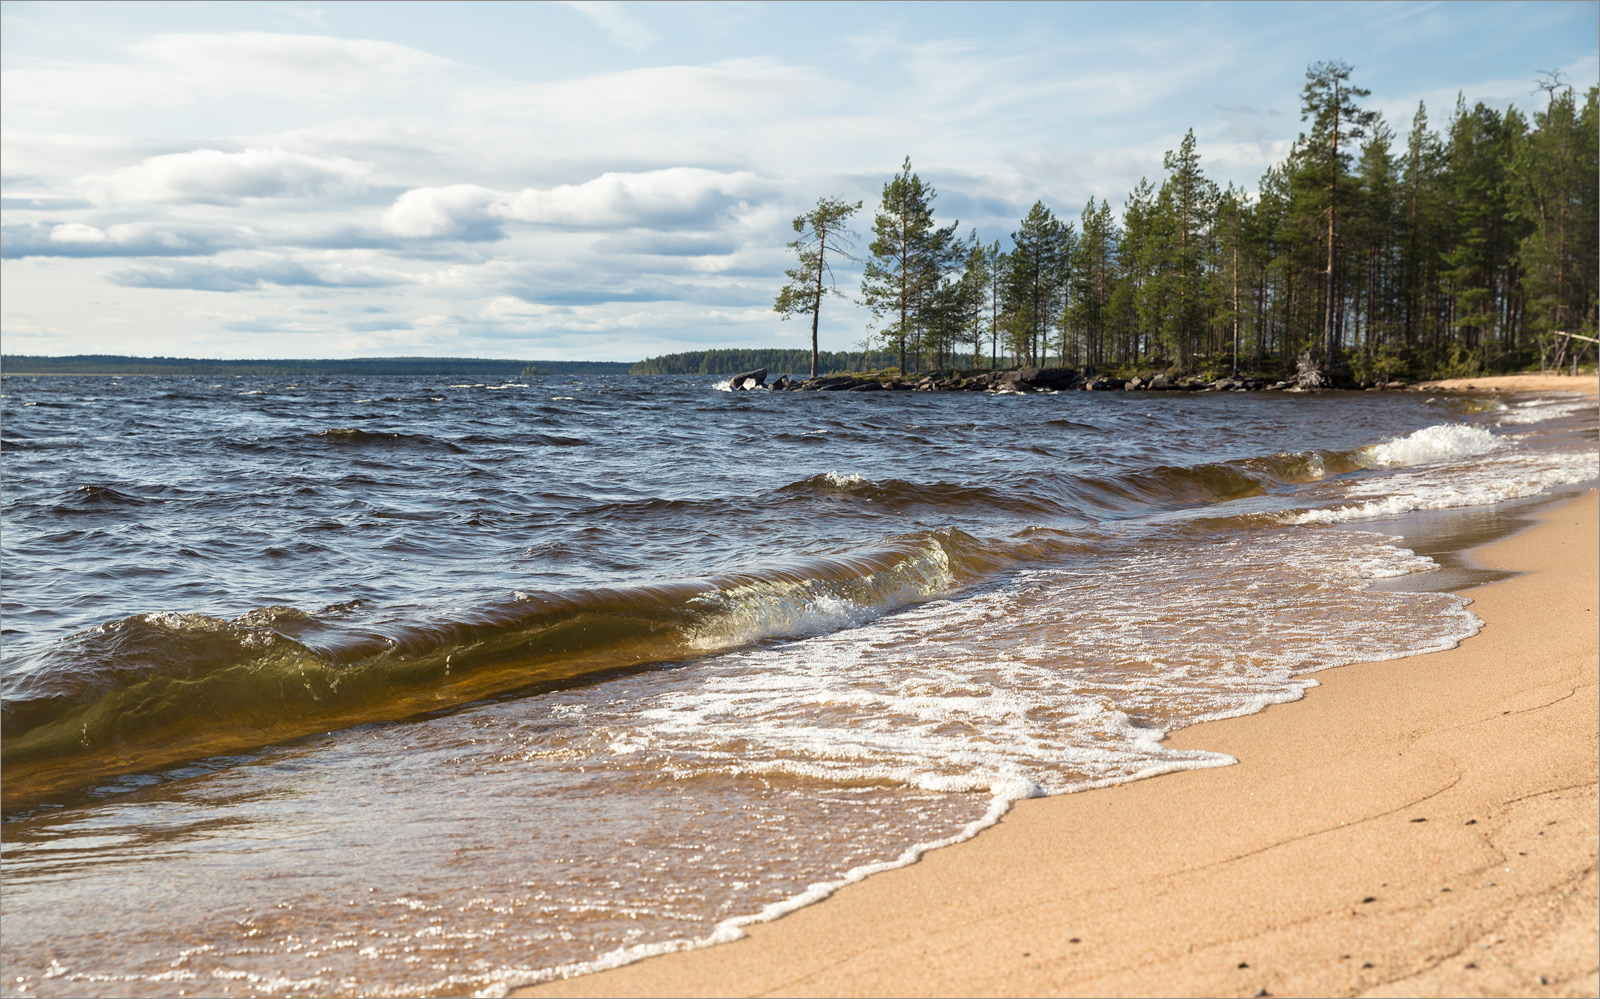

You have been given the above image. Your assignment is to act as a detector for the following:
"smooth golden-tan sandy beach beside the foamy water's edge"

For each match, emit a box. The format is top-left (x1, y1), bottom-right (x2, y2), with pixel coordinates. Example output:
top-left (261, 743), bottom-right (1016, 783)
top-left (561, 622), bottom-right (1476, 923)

top-left (515, 486), bottom-right (1600, 996)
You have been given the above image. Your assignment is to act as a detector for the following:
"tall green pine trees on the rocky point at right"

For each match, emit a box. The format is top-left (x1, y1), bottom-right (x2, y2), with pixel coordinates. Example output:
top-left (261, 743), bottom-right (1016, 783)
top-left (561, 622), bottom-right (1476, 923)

top-left (774, 62), bottom-right (1600, 383)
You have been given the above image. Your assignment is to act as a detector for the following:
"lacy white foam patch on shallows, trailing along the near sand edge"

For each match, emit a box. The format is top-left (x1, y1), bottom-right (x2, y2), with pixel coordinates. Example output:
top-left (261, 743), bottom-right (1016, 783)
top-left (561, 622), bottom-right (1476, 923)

top-left (478, 528), bottom-right (1478, 996)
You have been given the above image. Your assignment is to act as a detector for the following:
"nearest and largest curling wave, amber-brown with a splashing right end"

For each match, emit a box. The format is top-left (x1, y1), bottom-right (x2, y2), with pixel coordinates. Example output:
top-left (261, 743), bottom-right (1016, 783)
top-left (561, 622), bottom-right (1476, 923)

top-left (0, 530), bottom-right (998, 810)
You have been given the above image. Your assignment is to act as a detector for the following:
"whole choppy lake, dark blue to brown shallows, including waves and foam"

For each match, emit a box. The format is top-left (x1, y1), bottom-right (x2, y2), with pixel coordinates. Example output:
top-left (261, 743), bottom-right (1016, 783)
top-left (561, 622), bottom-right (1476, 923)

top-left (0, 376), bottom-right (1597, 996)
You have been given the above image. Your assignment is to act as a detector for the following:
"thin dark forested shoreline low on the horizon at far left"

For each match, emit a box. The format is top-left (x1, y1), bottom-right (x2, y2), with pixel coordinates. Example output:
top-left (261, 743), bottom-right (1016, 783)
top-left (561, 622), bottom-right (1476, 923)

top-left (0, 354), bottom-right (629, 378)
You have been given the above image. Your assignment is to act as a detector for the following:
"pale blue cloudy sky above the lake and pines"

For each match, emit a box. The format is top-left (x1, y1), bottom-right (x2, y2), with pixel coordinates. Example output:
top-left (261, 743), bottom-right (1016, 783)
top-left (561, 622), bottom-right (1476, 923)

top-left (0, 2), bottom-right (1600, 360)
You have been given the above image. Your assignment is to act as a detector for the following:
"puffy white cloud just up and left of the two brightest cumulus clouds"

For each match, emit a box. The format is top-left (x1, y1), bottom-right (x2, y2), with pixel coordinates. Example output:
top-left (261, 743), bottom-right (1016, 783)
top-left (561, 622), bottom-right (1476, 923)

top-left (78, 149), bottom-right (373, 205)
